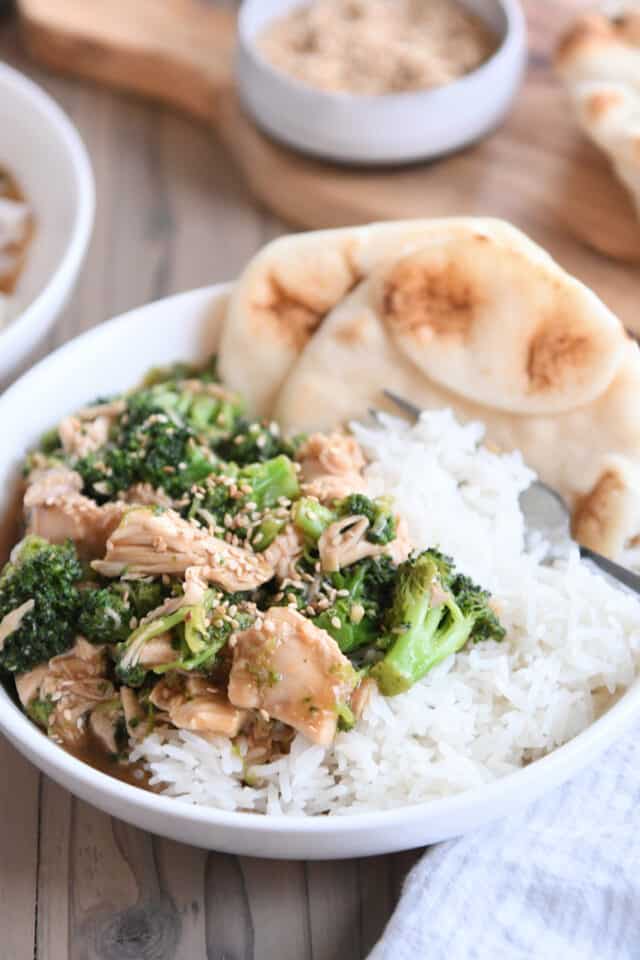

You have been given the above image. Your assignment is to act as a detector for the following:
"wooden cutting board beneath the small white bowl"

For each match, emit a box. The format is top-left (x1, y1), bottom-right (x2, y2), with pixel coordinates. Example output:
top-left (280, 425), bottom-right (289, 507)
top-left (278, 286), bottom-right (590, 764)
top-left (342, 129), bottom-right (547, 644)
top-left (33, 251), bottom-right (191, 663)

top-left (13, 0), bottom-right (640, 330)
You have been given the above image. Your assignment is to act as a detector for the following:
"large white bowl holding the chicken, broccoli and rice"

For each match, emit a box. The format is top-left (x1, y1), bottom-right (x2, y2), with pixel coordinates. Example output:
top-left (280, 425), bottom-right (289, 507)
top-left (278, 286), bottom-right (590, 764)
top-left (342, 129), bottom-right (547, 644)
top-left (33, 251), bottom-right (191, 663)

top-left (0, 286), bottom-right (640, 859)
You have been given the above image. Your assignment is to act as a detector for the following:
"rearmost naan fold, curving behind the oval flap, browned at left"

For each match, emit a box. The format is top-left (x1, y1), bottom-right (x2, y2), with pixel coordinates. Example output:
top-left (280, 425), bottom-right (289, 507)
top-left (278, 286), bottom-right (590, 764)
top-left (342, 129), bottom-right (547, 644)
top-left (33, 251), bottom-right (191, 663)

top-left (219, 218), bottom-right (552, 416)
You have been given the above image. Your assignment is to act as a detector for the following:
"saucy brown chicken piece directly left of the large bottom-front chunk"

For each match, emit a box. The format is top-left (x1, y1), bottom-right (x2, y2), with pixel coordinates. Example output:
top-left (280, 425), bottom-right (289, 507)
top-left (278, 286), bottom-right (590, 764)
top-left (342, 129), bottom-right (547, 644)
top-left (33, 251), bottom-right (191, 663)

top-left (149, 677), bottom-right (247, 738)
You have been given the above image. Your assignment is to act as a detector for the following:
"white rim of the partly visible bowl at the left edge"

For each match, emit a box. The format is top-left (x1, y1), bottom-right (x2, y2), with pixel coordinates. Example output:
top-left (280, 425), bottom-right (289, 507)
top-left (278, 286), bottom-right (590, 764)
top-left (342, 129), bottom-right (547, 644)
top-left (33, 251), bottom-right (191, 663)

top-left (0, 63), bottom-right (96, 349)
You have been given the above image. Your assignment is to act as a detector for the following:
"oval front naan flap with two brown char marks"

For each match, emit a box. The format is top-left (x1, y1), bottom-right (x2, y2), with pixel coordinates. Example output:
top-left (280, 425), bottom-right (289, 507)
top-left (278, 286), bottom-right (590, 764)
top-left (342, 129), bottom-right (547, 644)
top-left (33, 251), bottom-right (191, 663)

top-left (372, 230), bottom-right (626, 414)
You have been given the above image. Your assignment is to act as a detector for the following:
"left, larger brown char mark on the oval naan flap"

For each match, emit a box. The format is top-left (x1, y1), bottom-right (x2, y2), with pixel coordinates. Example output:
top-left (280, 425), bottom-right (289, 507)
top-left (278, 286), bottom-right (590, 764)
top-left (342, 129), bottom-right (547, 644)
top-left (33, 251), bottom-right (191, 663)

top-left (383, 259), bottom-right (480, 341)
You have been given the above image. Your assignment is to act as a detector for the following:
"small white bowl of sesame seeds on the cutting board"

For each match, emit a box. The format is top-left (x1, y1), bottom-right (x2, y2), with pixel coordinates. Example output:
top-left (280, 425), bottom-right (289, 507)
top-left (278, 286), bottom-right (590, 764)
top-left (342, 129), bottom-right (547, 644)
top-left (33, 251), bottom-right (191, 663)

top-left (236, 0), bottom-right (527, 164)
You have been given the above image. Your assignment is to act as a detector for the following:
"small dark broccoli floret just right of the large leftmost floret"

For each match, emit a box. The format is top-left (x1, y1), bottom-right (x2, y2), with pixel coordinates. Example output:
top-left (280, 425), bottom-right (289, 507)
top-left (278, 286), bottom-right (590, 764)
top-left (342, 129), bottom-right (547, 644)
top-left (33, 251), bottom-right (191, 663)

top-left (78, 580), bottom-right (163, 643)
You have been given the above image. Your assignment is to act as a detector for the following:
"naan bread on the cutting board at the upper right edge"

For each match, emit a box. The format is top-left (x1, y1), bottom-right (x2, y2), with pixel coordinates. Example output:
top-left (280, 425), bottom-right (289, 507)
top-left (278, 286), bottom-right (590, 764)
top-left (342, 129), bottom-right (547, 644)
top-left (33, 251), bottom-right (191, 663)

top-left (555, 10), bottom-right (640, 220)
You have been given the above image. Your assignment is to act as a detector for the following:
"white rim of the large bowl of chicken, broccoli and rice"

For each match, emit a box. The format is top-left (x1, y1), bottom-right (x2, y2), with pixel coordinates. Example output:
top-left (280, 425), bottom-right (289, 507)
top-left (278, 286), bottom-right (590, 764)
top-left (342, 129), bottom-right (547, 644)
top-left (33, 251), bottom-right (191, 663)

top-left (0, 284), bottom-right (640, 836)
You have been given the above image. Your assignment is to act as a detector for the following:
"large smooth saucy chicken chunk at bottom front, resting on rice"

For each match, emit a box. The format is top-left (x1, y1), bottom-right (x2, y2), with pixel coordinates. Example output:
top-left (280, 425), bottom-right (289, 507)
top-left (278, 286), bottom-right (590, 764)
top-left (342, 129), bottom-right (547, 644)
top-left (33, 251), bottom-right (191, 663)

top-left (229, 607), bottom-right (358, 747)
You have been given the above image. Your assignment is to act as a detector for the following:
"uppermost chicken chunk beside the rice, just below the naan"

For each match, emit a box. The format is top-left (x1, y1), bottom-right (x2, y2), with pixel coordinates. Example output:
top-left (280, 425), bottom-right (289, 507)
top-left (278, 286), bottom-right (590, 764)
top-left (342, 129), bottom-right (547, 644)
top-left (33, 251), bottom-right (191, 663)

top-left (297, 433), bottom-right (366, 503)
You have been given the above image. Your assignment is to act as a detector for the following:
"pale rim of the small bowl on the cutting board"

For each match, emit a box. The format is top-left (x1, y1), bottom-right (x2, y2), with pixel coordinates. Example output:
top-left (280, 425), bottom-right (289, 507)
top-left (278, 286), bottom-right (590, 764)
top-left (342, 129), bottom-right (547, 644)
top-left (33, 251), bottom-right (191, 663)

top-left (237, 0), bottom-right (526, 109)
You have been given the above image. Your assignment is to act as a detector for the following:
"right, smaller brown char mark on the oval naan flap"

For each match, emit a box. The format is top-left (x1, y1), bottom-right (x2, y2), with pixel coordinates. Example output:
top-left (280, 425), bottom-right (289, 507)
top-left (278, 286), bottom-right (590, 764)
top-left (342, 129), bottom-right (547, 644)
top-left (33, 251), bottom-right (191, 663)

top-left (527, 324), bottom-right (591, 393)
